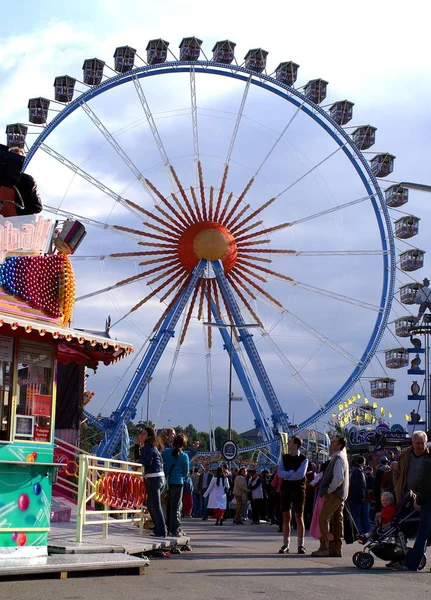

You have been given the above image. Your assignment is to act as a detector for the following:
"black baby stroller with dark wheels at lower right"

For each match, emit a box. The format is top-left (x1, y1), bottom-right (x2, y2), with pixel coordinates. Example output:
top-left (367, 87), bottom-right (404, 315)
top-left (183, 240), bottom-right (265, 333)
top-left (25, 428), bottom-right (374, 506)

top-left (352, 491), bottom-right (427, 570)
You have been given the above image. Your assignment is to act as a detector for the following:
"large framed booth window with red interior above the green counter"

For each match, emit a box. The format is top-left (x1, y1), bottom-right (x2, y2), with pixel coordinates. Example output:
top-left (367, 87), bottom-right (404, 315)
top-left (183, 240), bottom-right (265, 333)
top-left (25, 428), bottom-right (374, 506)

top-left (15, 340), bottom-right (54, 442)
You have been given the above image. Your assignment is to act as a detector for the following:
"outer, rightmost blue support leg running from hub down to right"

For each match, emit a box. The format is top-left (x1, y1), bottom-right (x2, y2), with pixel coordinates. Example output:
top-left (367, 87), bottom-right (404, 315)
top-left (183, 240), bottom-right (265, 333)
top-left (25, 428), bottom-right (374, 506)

top-left (211, 261), bottom-right (290, 432)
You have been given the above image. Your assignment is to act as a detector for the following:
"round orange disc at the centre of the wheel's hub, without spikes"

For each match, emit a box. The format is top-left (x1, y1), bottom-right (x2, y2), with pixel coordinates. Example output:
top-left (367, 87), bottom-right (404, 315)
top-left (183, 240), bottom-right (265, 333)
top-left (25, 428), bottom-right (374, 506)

top-left (178, 221), bottom-right (238, 273)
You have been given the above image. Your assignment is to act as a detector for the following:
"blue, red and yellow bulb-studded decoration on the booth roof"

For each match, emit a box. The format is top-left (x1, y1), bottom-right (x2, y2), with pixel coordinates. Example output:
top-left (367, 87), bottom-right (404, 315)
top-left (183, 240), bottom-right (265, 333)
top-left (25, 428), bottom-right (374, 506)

top-left (0, 254), bottom-right (76, 326)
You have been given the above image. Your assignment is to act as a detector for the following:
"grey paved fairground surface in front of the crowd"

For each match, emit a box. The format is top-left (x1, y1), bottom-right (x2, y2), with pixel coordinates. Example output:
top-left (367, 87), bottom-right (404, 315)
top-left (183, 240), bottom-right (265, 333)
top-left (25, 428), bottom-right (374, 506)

top-left (0, 519), bottom-right (431, 600)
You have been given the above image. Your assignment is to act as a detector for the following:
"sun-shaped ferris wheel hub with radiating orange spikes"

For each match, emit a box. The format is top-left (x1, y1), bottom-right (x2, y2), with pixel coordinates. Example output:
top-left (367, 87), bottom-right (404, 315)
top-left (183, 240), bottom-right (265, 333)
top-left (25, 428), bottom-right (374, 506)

top-left (111, 162), bottom-right (295, 346)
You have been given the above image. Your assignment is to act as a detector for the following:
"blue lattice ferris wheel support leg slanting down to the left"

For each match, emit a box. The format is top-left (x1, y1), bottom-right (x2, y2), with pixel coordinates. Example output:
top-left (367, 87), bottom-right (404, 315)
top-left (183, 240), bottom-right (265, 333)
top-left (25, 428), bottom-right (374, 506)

top-left (97, 259), bottom-right (207, 457)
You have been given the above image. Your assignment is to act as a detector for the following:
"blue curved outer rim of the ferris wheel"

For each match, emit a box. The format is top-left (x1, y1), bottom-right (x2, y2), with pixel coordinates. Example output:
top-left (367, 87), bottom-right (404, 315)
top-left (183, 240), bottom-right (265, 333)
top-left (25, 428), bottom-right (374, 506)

top-left (24, 61), bottom-right (396, 431)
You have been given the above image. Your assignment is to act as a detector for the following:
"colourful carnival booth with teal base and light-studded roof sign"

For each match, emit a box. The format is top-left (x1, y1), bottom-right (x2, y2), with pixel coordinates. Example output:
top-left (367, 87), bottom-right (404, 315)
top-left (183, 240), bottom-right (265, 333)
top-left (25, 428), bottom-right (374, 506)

top-left (0, 214), bottom-right (132, 558)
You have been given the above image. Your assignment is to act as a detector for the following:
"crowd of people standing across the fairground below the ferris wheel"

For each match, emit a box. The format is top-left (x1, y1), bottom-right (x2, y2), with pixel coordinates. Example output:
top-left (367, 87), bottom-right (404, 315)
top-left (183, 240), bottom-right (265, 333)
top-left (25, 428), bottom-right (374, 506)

top-left (138, 427), bottom-right (431, 570)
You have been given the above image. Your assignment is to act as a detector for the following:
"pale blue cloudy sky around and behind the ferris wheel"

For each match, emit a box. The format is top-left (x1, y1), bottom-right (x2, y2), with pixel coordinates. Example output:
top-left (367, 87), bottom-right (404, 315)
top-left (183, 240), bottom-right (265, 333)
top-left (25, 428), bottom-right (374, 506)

top-left (0, 0), bottom-right (431, 440)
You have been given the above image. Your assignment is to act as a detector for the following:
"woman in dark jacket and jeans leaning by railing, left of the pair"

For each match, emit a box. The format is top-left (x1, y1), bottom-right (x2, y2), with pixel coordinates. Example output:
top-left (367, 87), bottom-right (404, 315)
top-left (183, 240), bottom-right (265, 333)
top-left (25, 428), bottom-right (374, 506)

top-left (140, 427), bottom-right (166, 537)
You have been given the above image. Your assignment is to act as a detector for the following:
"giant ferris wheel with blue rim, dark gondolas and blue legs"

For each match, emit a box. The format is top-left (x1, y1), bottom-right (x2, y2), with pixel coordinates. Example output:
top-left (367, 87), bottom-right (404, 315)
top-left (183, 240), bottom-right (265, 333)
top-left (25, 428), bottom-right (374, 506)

top-left (7, 37), bottom-right (404, 454)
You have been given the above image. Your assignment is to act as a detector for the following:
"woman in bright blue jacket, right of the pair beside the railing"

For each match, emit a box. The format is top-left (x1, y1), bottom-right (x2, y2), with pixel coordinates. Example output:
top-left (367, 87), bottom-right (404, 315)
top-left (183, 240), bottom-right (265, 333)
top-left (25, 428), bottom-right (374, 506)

top-left (162, 433), bottom-right (190, 536)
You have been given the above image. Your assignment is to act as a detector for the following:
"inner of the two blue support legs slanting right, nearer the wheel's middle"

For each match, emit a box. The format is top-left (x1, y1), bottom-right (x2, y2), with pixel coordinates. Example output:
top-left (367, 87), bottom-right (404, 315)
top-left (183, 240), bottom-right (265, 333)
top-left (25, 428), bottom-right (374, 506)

top-left (211, 300), bottom-right (274, 442)
